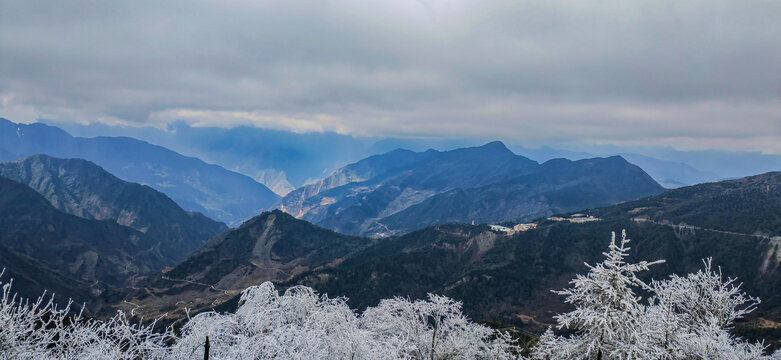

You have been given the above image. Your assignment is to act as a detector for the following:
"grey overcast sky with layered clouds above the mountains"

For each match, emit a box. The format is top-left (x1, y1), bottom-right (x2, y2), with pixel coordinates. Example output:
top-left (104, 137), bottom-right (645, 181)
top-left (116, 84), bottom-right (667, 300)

top-left (0, 0), bottom-right (781, 153)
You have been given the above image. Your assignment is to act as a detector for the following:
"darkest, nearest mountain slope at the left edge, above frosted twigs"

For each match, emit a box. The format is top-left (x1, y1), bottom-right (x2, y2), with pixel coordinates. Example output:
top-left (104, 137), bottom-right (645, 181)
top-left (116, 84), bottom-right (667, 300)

top-left (0, 178), bottom-right (166, 306)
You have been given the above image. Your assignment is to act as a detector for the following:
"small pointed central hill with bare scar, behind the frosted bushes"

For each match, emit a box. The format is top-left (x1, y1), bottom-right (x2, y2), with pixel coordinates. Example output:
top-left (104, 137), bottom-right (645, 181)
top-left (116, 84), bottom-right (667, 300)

top-left (121, 211), bottom-right (372, 317)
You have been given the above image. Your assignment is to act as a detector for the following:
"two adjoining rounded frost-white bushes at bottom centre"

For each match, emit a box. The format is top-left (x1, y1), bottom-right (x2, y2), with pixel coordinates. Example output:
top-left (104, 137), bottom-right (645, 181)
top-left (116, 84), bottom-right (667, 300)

top-left (172, 282), bottom-right (516, 359)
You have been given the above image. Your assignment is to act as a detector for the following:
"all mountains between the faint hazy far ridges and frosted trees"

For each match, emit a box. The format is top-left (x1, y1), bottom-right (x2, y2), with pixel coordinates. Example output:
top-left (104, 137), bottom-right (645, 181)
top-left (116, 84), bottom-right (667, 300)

top-left (0, 116), bottom-right (781, 344)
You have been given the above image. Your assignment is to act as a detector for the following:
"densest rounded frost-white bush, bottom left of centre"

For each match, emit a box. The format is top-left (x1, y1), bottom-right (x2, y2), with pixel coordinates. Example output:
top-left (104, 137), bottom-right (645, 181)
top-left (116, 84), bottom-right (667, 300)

top-left (172, 282), bottom-right (391, 359)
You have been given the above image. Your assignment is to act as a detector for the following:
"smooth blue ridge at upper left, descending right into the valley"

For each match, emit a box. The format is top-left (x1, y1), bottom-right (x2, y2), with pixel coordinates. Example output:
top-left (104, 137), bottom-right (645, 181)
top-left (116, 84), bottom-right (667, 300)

top-left (0, 119), bottom-right (279, 225)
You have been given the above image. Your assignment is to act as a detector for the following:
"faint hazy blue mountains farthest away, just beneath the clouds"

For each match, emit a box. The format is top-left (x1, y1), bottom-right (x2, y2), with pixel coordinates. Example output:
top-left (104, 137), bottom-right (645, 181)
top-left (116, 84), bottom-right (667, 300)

top-left (57, 122), bottom-right (768, 191)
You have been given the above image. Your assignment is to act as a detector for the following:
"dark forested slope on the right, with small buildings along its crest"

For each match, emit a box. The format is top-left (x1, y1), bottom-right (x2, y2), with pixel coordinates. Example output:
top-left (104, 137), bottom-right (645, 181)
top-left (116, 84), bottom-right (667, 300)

top-left (287, 173), bottom-right (781, 341)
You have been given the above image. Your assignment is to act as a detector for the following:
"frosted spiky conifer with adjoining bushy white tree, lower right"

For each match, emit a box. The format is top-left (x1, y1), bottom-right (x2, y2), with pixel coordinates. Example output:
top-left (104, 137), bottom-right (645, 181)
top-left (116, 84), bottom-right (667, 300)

top-left (533, 233), bottom-right (781, 359)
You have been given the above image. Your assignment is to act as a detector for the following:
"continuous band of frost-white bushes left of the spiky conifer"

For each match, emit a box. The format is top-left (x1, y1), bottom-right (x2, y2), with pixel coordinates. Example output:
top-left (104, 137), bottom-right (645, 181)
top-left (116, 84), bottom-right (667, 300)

top-left (0, 270), bottom-right (518, 360)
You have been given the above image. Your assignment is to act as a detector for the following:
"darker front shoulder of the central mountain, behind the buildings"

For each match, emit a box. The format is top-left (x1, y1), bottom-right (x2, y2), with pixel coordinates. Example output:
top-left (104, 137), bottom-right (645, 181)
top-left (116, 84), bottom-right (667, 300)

top-left (379, 156), bottom-right (663, 232)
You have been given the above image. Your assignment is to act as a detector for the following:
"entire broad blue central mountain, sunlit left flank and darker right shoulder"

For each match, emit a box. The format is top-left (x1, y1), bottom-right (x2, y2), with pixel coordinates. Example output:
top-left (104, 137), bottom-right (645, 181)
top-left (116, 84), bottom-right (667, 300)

top-left (272, 142), bottom-right (664, 236)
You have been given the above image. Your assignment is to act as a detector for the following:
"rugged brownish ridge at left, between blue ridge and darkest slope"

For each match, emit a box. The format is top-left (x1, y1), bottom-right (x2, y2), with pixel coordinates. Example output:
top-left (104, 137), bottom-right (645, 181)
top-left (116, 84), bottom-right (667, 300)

top-left (0, 155), bottom-right (228, 265)
